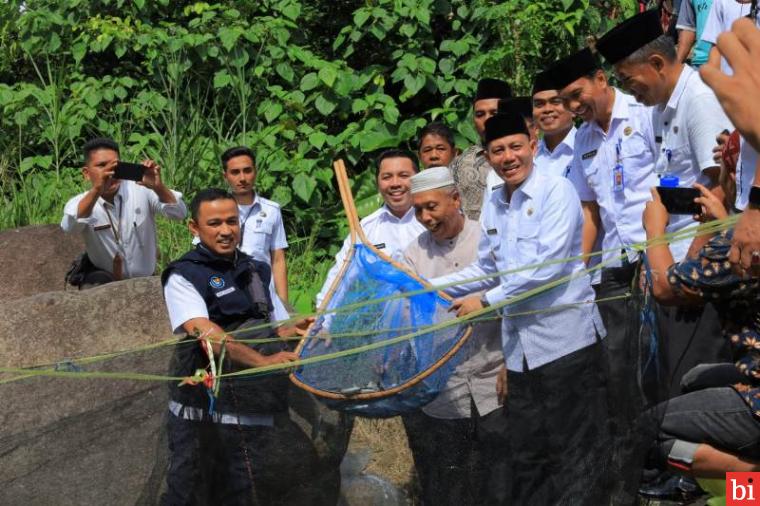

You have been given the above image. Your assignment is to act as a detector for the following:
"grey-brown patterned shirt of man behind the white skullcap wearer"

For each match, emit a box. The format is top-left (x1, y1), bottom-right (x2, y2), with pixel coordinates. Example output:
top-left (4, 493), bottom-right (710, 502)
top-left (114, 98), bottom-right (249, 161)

top-left (449, 144), bottom-right (491, 220)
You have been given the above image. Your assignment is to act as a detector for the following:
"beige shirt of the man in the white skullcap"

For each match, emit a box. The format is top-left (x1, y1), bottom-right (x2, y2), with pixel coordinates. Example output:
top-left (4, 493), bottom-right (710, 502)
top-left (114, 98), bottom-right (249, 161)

top-left (404, 220), bottom-right (504, 419)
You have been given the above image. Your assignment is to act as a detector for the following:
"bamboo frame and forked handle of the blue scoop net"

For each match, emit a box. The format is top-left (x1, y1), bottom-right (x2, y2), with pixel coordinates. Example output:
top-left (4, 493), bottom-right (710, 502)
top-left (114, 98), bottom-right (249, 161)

top-left (290, 160), bottom-right (472, 401)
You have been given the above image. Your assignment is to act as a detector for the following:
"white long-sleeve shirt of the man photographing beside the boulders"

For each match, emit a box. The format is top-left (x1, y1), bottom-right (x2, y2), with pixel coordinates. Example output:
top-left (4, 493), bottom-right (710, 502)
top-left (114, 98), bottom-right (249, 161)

top-left (61, 180), bottom-right (187, 278)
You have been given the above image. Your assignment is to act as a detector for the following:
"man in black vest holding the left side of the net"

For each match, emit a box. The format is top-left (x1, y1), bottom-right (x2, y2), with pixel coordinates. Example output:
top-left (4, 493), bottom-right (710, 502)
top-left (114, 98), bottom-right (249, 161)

top-left (161, 189), bottom-right (315, 505)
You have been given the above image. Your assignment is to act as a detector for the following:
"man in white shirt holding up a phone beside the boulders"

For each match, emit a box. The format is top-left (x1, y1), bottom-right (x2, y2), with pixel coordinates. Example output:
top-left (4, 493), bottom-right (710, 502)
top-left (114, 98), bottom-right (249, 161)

top-left (61, 138), bottom-right (187, 287)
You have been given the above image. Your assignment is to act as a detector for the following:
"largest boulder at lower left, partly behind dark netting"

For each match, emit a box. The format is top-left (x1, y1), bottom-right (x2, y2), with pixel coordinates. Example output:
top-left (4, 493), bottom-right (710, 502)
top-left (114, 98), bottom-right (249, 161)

top-left (0, 278), bottom-right (172, 505)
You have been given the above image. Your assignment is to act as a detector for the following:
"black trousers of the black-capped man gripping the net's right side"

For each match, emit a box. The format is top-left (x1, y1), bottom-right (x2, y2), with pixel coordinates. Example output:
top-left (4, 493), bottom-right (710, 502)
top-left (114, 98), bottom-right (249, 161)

top-left (506, 343), bottom-right (611, 506)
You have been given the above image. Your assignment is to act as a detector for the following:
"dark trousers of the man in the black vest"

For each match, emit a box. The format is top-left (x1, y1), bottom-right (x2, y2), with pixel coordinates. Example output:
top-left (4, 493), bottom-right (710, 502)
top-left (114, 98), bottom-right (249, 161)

top-left (161, 413), bottom-right (320, 506)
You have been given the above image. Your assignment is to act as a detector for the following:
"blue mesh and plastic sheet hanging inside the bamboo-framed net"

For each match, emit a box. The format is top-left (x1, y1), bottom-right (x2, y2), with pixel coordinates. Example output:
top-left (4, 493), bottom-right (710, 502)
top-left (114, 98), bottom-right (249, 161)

top-left (295, 244), bottom-right (467, 417)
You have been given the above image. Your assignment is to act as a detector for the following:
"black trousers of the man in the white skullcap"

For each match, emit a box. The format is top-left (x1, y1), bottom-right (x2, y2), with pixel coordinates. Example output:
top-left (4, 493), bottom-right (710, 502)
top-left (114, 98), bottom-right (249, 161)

top-left (402, 405), bottom-right (510, 506)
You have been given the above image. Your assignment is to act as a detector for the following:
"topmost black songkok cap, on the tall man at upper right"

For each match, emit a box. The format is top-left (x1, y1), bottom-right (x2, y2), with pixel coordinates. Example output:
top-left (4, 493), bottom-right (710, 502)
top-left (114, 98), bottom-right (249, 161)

top-left (596, 10), bottom-right (662, 65)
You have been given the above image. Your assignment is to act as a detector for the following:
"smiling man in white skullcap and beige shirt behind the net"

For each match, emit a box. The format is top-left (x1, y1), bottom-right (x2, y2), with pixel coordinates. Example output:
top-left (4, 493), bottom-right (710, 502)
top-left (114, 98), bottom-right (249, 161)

top-left (403, 167), bottom-right (509, 506)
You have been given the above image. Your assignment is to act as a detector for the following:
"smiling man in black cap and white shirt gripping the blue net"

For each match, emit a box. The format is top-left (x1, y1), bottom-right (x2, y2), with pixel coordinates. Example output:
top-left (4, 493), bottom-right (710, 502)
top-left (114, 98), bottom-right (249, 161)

top-left (431, 112), bottom-right (609, 504)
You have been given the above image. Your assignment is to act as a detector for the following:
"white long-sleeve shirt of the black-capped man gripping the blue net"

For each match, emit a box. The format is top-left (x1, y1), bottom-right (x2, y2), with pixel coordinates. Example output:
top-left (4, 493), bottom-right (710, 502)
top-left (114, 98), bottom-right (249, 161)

top-left (430, 170), bottom-right (606, 372)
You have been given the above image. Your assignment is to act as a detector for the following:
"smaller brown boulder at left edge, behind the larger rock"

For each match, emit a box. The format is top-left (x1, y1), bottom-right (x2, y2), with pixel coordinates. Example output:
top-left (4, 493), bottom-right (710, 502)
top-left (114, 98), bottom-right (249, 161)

top-left (0, 225), bottom-right (84, 301)
